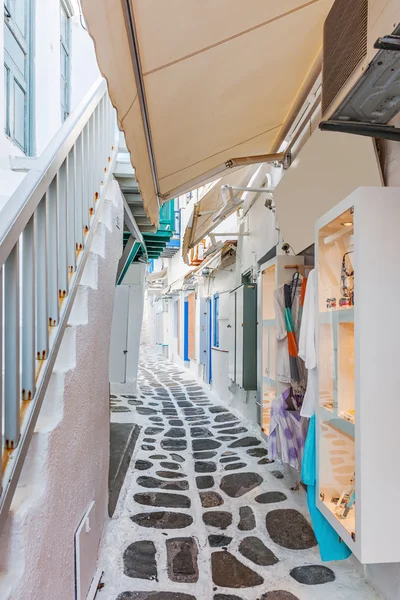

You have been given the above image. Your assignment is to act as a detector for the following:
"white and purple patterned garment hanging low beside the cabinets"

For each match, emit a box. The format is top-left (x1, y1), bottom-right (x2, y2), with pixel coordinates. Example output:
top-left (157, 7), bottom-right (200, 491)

top-left (268, 388), bottom-right (308, 471)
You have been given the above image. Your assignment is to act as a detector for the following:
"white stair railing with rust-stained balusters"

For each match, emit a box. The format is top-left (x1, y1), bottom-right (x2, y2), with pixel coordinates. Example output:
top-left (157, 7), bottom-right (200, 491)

top-left (0, 80), bottom-right (118, 530)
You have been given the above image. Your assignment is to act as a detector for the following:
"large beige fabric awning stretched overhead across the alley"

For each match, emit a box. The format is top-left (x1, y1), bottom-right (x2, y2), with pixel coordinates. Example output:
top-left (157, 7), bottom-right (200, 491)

top-left (82, 0), bottom-right (333, 223)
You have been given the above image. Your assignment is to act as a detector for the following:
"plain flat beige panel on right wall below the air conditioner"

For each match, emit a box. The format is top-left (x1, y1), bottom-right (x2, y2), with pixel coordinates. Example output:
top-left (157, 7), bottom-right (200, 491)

top-left (274, 129), bottom-right (382, 254)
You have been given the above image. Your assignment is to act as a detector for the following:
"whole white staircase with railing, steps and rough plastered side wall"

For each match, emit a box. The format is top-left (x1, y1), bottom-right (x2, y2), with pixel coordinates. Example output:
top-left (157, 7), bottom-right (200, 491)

top-left (0, 81), bottom-right (123, 600)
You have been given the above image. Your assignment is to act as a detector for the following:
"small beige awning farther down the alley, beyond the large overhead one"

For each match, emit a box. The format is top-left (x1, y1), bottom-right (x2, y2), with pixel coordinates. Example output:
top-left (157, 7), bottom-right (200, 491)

top-left (182, 165), bottom-right (259, 257)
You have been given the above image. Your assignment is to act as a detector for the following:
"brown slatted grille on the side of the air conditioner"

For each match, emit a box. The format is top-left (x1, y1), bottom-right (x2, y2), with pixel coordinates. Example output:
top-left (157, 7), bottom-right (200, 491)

top-left (322, 0), bottom-right (368, 114)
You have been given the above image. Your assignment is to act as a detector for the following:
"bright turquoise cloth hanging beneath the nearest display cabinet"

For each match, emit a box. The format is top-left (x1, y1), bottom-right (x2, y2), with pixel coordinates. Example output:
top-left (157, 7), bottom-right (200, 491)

top-left (301, 416), bottom-right (351, 562)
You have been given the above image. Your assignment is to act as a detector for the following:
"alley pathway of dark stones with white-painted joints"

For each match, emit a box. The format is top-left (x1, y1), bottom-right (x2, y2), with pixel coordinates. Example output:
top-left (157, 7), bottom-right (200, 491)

top-left (98, 353), bottom-right (378, 600)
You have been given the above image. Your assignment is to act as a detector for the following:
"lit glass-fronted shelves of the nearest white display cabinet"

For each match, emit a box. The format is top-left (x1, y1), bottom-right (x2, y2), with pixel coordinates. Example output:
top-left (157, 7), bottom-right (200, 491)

top-left (318, 207), bottom-right (356, 538)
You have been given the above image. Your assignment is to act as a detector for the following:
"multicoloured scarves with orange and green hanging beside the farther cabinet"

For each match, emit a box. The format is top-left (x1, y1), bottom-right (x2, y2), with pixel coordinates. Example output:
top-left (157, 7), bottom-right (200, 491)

top-left (274, 285), bottom-right (305, 384)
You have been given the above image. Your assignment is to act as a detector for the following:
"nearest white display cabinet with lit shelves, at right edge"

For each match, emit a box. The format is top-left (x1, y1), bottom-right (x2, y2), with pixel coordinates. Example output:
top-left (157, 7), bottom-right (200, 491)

top-left (316, 187), bottom-right (400, 563)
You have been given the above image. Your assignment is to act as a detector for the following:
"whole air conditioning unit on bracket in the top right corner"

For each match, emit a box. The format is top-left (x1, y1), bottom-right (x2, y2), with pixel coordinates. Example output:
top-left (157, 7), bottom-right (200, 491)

top-left (320, 0), bottom-right (400, 141)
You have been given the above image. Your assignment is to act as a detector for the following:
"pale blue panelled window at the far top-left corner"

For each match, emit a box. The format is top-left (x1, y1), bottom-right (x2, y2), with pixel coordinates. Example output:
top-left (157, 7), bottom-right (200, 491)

top-left (4, 0), bottom-right (31, 154)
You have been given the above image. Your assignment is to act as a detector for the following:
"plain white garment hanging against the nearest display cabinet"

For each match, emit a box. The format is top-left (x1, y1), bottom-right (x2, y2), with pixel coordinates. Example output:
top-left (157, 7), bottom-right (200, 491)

top-left (299, 269), bottom-right (318, 418)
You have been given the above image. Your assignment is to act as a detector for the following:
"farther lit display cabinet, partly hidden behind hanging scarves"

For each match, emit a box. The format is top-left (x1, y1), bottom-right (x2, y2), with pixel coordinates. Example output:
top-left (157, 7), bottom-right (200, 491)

top-left (258, 254), bottom-right (304, 435)
